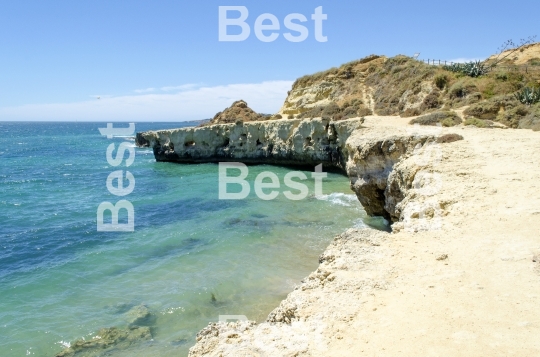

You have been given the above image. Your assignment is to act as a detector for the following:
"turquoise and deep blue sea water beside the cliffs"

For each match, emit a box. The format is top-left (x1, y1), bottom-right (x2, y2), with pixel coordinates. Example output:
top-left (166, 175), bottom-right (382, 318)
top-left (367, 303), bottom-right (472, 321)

top-left (0, 122), bottom-right (383, 356)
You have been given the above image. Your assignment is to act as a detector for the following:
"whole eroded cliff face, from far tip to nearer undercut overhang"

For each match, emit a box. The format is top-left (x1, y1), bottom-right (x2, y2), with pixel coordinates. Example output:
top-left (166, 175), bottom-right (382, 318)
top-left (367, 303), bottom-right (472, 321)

top-left (136, 119), bottom-right (460, 222)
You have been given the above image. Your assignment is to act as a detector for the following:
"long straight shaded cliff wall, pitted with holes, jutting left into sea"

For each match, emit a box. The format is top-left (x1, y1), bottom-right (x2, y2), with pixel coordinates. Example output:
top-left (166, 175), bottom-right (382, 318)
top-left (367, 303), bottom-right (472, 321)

top-left (136, 119), bottom-right (361, 170)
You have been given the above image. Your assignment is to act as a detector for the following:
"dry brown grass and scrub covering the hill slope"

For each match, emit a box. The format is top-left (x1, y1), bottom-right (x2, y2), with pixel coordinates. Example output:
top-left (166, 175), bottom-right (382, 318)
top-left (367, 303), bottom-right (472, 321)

top-left (283, 48), bottom-right (540, 127)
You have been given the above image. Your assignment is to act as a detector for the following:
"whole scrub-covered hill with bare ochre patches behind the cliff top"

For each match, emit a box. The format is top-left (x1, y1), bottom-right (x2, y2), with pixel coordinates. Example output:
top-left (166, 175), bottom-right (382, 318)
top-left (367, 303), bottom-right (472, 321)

top-left (280, 43), bottom-right (540, 128)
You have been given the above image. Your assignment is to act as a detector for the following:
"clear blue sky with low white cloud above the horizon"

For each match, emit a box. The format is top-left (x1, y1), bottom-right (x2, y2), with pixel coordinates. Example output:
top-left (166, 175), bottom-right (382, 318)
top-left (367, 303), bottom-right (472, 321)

top-left (0, 0), bottom-right (540, 121)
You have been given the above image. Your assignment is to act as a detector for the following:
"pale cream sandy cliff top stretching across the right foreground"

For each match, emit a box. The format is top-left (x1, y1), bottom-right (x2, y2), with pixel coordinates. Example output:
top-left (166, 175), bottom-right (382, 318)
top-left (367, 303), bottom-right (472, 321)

top-left (190, 117), bottom-right (540, 357)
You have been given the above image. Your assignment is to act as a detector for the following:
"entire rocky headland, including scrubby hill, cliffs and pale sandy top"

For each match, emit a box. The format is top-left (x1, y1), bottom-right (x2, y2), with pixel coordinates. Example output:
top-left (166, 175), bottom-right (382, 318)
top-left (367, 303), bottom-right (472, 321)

top-left (132, 45), bottom-right (540, 357)
